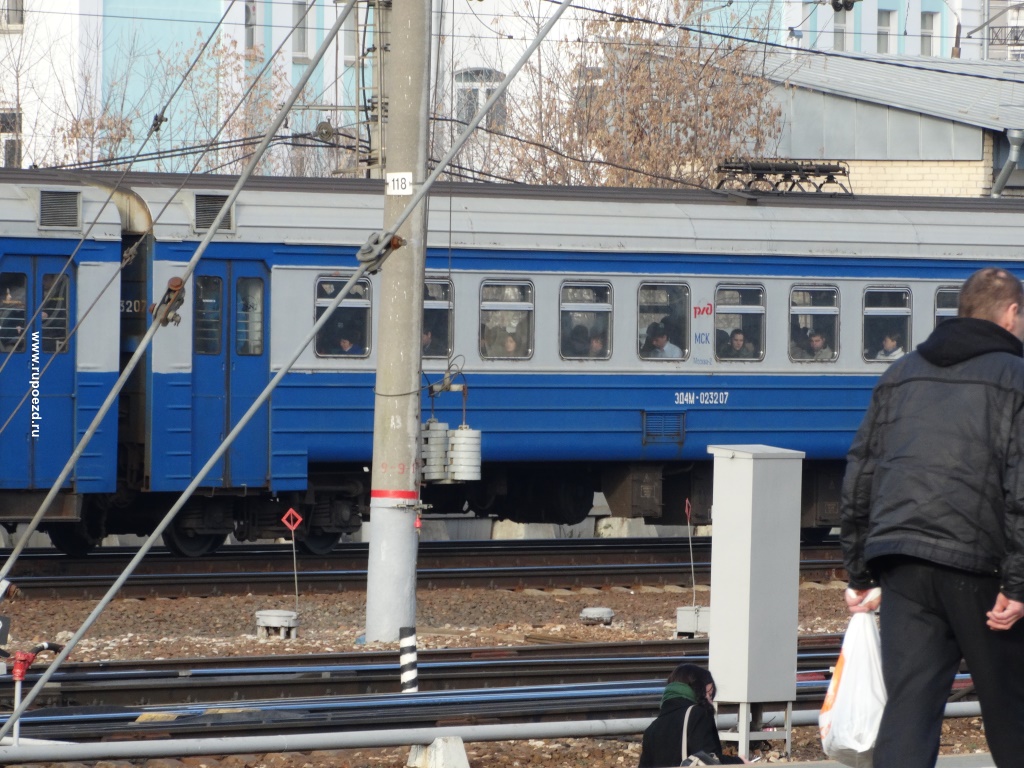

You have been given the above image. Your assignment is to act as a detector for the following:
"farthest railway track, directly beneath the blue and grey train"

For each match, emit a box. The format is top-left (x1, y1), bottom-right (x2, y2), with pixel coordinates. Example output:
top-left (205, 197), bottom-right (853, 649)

top-left (4, 539), bottom-right (844, 599)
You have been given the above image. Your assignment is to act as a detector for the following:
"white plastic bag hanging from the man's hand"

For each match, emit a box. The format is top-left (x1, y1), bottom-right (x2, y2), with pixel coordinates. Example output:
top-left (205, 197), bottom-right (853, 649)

top-left (818, 613), bottom-right (886, 768)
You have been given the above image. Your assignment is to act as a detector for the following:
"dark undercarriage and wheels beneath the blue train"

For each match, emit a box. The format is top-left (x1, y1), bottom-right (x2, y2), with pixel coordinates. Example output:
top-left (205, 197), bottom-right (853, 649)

top-left (0, 461), bottom-right (844, 557)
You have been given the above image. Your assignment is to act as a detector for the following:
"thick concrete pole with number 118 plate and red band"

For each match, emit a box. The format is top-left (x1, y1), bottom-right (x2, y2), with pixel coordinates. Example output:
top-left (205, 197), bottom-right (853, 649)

top-left (367, 0), bottom-right (431, 642)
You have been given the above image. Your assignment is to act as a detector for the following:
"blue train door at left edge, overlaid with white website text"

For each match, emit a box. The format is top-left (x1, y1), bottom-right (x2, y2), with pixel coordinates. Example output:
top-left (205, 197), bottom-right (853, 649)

top-left (0, 256), bottom-right (76, 489)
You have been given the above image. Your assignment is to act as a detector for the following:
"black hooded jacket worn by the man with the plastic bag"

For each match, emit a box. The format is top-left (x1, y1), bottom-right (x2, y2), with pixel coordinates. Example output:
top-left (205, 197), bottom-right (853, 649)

top-left (842, 317), bottom-right (1024, 601)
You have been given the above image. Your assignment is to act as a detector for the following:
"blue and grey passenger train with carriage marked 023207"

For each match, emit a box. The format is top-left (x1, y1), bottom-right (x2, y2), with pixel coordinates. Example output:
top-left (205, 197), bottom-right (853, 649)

top-left (0, 171), bottom-right (1024, 555)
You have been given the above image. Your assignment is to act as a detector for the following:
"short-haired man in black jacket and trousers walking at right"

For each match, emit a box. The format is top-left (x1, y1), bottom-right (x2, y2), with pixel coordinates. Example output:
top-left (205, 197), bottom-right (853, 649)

top-left (842, 268), bottom-right (1024, 768)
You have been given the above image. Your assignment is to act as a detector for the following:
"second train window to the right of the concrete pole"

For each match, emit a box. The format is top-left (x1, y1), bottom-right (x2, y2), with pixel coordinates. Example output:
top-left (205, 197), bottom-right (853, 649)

top-left (480, 283), bottom-right (534, 358)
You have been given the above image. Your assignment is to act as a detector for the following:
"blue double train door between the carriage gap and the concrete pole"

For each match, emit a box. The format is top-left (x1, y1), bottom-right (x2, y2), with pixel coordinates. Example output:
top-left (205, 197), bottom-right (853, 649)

top-left (193, 260), bottom-right (269, 487)
